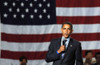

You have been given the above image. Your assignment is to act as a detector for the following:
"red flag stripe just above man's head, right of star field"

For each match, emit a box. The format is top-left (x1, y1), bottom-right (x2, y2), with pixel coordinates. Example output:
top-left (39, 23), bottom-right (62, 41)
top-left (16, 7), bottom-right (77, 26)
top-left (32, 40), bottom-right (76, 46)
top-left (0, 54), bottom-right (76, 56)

top-left (56, 16), bottom-right (100, 24)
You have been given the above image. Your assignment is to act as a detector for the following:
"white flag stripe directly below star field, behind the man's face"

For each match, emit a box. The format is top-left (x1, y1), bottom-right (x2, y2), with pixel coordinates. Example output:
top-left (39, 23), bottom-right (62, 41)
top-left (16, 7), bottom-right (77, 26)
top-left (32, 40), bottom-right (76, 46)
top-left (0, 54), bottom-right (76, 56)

top-left (1, 24), bottom-right (100, 34)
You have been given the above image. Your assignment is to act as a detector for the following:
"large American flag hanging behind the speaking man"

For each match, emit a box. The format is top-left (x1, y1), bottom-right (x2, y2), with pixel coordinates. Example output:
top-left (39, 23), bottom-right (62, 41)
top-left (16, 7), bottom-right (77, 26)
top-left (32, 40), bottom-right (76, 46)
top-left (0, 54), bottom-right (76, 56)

top-left (0, 0), bottom-right (100, 65)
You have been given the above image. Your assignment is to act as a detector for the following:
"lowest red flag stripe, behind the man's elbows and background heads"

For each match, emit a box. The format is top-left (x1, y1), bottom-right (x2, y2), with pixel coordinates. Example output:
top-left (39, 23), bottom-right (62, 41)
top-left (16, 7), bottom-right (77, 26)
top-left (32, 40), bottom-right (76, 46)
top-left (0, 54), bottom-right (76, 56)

top-left (1, 50), bottom-right (100, 60)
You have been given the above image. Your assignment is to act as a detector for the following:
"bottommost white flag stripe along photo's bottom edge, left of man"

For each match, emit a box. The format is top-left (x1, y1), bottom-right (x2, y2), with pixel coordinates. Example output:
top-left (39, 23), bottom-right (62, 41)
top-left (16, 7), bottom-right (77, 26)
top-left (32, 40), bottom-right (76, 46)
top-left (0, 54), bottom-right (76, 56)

top-left (0, 58), bottom-right (52, 65)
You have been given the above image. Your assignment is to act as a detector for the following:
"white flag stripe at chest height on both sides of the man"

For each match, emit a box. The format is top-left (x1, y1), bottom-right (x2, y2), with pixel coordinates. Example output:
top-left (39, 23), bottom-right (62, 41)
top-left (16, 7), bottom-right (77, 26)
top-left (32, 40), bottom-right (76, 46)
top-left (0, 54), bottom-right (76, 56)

top-left (1, 41), bottom-right (100, 51)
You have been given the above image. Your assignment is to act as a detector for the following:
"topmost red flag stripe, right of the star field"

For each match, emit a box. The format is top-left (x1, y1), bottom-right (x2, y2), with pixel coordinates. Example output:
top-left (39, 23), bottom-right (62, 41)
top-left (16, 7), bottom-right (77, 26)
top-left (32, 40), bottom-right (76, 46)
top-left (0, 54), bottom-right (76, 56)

top-left (56, 0), bottom-right (100, 7)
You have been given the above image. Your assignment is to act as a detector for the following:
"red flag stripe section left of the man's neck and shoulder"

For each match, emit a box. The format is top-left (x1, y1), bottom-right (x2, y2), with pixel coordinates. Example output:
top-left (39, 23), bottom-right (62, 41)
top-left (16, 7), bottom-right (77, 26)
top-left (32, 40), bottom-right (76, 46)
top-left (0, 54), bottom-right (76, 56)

top-left (1, 33), bottom-right (61, 42)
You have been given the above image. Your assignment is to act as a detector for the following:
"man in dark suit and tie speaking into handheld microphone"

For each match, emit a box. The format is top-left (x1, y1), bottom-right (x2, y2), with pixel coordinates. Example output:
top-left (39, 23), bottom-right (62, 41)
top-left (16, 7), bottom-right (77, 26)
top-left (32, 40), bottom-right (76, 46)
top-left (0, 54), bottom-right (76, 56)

top-left (45, 22), bottom-right (83, 65)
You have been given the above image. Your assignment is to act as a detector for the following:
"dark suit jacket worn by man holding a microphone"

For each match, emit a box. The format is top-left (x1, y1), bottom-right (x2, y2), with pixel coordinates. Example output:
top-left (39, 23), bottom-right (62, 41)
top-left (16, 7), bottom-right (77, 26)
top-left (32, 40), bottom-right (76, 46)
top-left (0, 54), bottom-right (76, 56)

top-left (45, 38), bottom-right (83, 65)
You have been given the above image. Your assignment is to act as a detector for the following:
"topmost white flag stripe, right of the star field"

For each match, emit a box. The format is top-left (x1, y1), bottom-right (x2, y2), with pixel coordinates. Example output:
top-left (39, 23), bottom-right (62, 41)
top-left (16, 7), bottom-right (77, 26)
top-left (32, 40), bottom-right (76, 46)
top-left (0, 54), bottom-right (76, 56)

top-left (56, 7), bottom-right (100, 16)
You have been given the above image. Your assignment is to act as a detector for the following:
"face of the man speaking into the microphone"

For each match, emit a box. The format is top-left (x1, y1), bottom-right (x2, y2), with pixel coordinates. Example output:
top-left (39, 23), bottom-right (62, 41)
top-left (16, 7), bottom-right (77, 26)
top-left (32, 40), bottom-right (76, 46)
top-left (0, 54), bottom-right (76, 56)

top-left (61, 24), bottom-right (73, 38)
